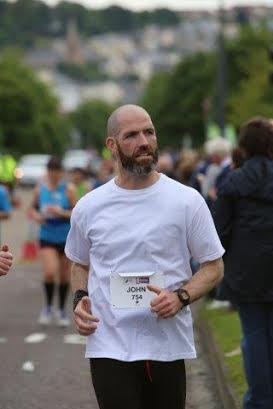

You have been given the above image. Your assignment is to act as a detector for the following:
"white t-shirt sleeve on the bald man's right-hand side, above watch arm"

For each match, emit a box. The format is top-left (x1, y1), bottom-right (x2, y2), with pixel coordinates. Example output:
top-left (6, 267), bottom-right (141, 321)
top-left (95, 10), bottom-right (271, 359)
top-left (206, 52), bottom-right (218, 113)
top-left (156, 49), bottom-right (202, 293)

top-left (188, 200), bottom-right (225, 263)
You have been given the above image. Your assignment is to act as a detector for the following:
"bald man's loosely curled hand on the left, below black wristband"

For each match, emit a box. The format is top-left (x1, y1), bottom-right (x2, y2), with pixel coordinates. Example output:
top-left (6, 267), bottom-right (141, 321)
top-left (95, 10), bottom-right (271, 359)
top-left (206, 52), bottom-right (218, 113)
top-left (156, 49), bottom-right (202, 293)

top-left (74, 296), bottom-right (99, 336)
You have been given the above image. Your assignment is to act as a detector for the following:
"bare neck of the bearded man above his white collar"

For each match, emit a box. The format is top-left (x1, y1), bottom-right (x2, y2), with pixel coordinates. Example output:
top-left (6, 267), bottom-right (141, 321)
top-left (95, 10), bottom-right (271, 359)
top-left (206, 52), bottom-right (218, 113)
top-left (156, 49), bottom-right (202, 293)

top-left (115, 170), bottom-right (160, 190)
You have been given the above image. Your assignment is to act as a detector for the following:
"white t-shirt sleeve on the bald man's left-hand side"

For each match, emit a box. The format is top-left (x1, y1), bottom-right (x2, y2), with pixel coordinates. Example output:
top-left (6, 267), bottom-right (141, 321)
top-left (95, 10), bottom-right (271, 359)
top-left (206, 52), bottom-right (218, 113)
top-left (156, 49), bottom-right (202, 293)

top-left (65, 208), bottom-right (91, 266)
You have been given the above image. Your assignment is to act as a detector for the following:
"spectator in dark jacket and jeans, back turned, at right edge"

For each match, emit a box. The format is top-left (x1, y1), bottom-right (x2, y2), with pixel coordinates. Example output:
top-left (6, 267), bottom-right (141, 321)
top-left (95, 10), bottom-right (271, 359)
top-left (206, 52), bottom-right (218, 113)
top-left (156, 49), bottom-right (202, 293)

top-left (214, 117), bottom-right (273, 409)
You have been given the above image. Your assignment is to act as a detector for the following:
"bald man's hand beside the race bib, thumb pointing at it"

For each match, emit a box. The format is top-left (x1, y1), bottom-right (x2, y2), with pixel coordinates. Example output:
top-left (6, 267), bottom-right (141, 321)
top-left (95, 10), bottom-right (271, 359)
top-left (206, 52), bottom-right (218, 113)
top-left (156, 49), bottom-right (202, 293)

top-left (147, 284), bottom-right (182, 318)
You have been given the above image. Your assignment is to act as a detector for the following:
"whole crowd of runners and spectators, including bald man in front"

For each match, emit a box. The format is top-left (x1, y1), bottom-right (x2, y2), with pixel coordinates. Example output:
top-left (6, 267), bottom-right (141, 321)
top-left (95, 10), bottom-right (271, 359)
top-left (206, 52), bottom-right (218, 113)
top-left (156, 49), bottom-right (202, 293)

top-left (0, 105), bottom-right (273, 409)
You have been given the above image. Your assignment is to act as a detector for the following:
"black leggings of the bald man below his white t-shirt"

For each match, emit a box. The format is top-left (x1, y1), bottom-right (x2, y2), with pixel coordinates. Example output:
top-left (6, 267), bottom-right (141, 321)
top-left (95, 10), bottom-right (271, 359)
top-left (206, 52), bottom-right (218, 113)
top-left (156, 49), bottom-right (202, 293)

top-left (90, 358), bottom-right (186, 409)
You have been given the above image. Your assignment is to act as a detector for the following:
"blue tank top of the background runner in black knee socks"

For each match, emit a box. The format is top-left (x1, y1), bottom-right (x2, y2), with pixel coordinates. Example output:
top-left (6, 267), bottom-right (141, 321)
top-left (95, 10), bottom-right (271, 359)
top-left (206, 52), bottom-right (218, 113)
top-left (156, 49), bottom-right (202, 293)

top-left (39, 183), bottom-right (71, 244)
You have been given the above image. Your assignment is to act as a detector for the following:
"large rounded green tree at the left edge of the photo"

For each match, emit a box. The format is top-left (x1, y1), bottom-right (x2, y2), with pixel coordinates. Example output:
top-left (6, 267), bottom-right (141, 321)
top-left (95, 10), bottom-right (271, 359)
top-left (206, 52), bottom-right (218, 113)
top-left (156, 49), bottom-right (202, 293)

top-left (0, 49), bottom-right (68, 154)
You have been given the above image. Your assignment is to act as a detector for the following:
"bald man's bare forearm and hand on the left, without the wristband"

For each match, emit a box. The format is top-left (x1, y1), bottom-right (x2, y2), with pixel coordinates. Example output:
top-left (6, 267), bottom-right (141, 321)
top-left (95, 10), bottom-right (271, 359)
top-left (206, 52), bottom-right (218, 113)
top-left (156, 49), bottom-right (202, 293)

top-left (71, 263), bottom-right (99, 335)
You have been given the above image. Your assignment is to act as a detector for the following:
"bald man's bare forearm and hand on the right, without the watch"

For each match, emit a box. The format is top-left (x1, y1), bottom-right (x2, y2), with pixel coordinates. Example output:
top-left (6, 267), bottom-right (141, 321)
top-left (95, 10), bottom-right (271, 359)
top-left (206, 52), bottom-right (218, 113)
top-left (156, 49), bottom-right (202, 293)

top-left (148, 258), bottom-right (224, 318)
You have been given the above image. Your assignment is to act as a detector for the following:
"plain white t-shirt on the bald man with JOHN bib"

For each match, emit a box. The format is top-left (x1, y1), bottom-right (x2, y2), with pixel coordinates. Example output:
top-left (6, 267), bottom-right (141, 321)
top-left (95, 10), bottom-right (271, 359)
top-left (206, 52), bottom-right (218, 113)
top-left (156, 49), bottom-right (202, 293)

top-left (65, 174), bottom-right (224, 361)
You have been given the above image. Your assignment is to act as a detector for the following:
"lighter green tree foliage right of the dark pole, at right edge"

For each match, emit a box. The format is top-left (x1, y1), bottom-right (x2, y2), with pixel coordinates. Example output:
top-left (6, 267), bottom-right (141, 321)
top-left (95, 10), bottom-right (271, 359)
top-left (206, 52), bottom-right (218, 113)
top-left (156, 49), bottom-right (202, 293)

top-left (225, 27), bottom-right (273, 127)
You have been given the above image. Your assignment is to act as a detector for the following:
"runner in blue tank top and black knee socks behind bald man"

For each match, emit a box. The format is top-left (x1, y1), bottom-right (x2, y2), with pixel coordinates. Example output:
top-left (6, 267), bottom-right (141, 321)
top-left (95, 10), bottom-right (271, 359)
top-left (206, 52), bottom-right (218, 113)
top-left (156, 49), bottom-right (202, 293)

top-left (30, 158), bottom-right (77, 326)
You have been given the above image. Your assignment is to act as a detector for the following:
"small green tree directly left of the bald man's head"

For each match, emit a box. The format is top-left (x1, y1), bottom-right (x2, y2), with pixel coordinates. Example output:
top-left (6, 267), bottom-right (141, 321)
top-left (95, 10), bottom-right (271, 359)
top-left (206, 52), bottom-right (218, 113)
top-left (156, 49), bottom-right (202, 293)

top-left (71, 100), bottom-right (116, 150)
